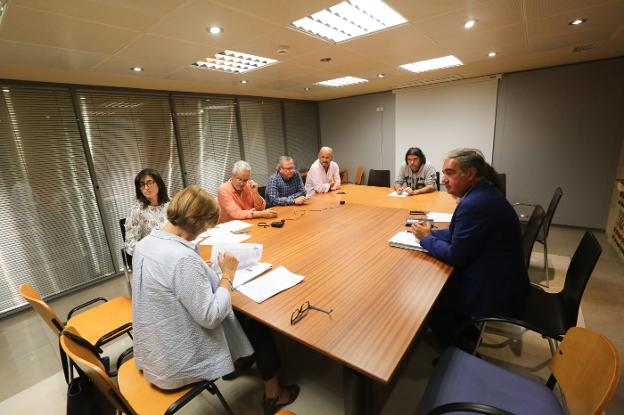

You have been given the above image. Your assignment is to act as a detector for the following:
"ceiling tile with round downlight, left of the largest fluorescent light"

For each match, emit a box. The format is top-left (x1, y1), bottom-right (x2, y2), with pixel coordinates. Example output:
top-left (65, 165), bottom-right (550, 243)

top-left (150, 0), bottom-right (276, 48)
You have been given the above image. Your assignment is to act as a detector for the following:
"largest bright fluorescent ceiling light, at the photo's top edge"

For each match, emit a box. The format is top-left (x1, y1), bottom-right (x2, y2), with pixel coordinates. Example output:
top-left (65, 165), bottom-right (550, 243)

top-left (291, 0), bottom-right (407, 43)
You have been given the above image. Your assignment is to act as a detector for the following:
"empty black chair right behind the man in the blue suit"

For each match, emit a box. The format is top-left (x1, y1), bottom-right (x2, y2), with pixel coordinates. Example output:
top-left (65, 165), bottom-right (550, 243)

top-left (473, 232), bottom-right (602, 354)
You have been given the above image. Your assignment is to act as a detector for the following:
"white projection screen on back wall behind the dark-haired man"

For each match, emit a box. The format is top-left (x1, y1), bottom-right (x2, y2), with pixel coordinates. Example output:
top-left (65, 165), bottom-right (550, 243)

top-left (395, 78), bottom-right (498, 171)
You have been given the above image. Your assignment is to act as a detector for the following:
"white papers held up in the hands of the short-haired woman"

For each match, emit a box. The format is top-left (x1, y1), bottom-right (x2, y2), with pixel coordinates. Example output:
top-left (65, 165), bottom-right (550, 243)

top-left (210, 244), bottom-right (271, 289)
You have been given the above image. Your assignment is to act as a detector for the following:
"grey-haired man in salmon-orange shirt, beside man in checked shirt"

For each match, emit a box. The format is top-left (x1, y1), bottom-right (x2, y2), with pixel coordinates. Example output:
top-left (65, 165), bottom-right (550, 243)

top-left (218, 160), bottom-right (277, 223)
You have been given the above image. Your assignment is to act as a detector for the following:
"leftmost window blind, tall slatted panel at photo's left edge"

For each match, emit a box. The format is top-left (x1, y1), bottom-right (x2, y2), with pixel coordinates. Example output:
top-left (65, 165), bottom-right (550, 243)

top-left (0, 85), bottom-right (115, 311)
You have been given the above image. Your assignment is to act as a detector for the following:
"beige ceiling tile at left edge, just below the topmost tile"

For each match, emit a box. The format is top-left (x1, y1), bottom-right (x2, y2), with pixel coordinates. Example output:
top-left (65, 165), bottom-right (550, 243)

top-left (0, 5), bottom-right (137, 53)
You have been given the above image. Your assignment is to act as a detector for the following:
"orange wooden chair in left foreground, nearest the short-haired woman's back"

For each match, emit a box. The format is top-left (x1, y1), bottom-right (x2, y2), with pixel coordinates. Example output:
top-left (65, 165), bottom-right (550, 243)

top-left (61, 326), bottom-right (232, 415)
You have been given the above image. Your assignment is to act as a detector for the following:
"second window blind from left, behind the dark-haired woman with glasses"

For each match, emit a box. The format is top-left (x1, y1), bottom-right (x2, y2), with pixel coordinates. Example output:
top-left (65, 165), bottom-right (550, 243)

top-left (76, 89), bottom-right (183, 269)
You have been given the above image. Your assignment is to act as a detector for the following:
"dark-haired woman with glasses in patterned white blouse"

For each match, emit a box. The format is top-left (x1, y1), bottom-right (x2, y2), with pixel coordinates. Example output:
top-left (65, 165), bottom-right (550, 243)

top-left (125, 169), bottom-right (169, 255)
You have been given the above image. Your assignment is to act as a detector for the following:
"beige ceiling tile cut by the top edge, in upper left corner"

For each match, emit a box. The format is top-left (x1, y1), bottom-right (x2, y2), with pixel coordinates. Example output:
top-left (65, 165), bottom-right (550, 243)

top-left (11, 0), bottom-right (180, 30)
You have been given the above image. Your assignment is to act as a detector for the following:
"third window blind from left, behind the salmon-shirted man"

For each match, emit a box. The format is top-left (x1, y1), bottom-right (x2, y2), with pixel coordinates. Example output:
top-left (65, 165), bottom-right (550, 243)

top-left (174, 95), bottom-right (241, 195)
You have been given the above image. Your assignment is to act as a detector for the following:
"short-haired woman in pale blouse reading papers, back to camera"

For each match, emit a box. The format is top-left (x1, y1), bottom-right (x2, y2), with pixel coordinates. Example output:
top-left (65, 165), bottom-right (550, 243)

top-left (132, 186), bottom-right (299, 414)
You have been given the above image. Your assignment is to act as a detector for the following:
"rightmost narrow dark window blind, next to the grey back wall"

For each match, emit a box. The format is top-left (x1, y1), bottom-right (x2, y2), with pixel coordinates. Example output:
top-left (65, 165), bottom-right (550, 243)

top-left (284, 101), bottom-right (320, 169)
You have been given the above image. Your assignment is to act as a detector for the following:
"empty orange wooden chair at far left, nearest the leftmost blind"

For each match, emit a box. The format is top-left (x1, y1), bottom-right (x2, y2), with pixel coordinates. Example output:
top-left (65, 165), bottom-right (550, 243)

top-left (19, 284), bottom-right (132, 381)
